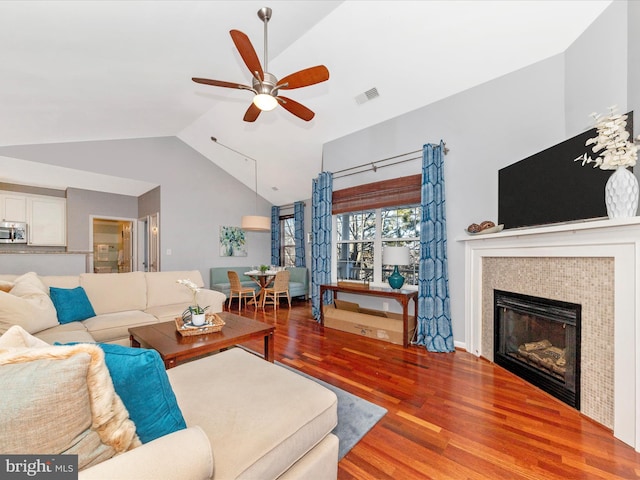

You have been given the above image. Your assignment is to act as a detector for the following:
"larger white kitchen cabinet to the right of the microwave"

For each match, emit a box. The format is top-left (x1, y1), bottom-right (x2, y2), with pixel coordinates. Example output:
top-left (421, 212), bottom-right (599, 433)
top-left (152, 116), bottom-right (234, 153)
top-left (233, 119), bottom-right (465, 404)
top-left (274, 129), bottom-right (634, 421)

top-left (27, 195), bottom-right (67, 246)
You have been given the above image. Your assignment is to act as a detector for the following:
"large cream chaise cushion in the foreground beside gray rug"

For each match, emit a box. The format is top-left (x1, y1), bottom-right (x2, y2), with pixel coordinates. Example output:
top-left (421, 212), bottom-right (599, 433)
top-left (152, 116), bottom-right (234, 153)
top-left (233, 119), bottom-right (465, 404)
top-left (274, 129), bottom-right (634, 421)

top-left (167, 348), bottom-right (337, 479)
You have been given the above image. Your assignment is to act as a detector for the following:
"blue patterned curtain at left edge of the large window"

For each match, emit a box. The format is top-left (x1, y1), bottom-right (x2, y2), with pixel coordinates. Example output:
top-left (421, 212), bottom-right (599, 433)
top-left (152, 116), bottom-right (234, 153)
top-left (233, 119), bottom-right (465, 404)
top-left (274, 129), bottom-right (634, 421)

top-left (311, 172), bottom-right (333, 321)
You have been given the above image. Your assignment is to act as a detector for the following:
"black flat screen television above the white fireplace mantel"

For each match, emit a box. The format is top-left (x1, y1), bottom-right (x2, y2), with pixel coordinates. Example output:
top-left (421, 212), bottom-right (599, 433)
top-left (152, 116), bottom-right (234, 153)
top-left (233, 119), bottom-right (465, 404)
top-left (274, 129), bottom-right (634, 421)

top-left (498, 112), bottom-right (633, 229)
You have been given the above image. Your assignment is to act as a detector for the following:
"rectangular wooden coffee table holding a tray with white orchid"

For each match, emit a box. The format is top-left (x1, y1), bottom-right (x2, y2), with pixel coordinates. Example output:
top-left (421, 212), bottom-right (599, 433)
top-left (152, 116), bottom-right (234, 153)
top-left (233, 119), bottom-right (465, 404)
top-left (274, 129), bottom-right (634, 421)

top-left (129, 312), bottom-right (276, 369)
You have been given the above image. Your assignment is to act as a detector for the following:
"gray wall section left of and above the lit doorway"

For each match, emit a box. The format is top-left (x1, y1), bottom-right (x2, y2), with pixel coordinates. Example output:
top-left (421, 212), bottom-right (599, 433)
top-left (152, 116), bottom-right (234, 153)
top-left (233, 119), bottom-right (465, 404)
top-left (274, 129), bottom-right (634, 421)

top-left (67, 188), bottom-right (138, 252)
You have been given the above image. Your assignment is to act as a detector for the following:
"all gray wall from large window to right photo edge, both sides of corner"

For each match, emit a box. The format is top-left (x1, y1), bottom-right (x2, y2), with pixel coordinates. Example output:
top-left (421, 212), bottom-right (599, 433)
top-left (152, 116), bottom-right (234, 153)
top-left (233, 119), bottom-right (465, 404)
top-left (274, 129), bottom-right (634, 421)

top-left (323, 2), bottom-right (640, 345)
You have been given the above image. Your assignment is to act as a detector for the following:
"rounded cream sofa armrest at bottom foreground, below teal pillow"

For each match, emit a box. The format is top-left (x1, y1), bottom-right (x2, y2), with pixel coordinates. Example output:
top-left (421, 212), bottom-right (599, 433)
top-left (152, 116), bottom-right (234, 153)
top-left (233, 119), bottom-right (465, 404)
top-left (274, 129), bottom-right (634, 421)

top-left (78, 427), bottom-right (213, 480)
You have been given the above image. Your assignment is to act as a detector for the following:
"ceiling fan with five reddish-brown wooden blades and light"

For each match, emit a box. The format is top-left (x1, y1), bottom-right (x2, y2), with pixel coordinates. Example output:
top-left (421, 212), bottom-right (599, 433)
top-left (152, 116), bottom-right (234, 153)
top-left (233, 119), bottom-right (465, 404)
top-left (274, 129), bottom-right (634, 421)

top-left (191, 7), bottom-right (329, 122)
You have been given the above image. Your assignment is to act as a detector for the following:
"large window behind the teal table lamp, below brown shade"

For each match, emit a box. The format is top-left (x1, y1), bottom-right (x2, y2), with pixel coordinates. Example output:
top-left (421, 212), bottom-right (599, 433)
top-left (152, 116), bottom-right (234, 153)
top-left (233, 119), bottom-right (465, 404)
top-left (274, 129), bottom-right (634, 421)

top-left (335, 205), bottom-right (420, 285)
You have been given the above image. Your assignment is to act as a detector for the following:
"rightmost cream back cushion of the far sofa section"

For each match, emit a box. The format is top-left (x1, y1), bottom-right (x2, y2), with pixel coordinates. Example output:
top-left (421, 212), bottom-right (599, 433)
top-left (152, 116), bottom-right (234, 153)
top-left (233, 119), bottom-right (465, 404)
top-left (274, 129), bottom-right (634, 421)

top-left (143, 270), bottom-right (204, 310)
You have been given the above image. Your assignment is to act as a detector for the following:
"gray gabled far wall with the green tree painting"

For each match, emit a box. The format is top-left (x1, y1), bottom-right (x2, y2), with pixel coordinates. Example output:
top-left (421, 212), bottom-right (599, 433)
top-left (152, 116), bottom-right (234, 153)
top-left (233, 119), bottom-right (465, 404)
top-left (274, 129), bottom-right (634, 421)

top-left (0, 137), bottom-right (271, 284)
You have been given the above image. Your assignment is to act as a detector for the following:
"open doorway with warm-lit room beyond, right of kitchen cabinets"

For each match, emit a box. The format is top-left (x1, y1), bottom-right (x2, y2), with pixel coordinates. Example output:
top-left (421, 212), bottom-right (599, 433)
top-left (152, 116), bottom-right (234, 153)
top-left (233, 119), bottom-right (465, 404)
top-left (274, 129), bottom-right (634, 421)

top-left (92, 217), bottom-right (136, 273)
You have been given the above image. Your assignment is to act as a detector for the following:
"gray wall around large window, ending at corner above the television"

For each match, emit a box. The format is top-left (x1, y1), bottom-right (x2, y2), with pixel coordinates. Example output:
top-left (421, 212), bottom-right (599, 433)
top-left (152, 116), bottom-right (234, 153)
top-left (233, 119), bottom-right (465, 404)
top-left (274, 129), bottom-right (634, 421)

top-left (324, 56), bottom-right (564, 342)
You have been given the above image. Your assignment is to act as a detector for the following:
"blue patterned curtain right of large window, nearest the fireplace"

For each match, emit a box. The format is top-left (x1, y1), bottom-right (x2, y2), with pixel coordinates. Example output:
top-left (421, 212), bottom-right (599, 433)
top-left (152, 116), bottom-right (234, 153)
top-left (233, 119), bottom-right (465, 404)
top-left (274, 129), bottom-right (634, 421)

top-left (416, 142), bottom-right (454, 352)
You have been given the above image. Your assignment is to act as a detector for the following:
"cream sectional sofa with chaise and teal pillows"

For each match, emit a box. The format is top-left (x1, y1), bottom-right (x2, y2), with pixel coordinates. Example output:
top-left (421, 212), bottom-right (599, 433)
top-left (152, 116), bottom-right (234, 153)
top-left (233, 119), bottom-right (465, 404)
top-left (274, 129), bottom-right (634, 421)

top-left (0, 272), bottom-right (338, 480)
